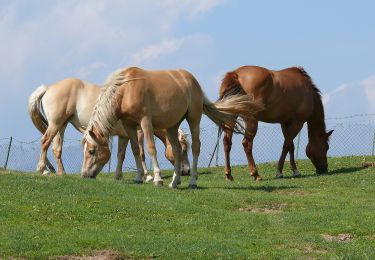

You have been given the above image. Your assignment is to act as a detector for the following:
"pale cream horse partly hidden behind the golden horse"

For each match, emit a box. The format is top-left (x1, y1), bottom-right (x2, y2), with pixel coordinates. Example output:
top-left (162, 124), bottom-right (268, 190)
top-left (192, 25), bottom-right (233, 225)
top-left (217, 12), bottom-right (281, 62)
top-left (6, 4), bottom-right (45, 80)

top-left (29, 78), bottom-right (190, 181)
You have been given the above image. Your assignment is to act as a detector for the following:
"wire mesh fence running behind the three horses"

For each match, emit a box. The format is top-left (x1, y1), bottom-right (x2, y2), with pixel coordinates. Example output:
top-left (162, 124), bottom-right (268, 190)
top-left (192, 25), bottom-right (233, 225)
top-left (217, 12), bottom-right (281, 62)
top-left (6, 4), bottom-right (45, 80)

top-left (0, 115), bottom-right (375, 173)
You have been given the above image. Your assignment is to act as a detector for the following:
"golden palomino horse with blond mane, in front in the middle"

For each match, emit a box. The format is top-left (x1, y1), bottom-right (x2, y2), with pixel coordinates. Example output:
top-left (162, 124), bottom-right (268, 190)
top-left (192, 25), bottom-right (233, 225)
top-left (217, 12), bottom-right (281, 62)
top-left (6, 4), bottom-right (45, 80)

top-left (82, 67), bottom-right (258, 188)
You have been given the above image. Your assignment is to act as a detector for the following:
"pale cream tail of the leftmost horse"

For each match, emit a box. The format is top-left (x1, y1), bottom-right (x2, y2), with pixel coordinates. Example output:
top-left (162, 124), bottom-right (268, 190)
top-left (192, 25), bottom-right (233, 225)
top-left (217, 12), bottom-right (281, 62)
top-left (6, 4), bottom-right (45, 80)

top-left (28, 85), bottom-right (48, 134)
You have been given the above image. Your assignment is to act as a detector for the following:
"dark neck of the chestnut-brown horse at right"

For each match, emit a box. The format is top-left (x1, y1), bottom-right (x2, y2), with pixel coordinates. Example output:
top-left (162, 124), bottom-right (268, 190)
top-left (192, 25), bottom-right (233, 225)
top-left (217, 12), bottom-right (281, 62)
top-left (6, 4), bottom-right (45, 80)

top-left (307, 93), bottom-right (326, 140)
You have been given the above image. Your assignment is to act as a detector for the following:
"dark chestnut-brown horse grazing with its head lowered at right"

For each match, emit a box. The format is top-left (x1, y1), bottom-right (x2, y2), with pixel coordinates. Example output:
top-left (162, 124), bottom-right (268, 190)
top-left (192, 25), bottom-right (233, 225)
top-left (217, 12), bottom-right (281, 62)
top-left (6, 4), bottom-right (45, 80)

top-left (219, 66), bottom-right (333, 180)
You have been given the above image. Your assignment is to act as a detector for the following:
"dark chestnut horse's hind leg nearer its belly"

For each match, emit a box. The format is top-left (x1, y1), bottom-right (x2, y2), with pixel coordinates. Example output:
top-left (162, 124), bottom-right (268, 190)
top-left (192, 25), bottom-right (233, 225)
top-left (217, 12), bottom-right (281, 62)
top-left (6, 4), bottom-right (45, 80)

top-left (242, 119), bottom-right (262, 181)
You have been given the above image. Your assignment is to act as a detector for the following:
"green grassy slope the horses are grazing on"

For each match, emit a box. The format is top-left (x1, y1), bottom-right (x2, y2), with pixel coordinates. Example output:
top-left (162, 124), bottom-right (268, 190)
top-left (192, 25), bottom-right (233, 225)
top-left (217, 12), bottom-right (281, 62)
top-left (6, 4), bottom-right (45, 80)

top-left (0, 157), bottom-right (375, 259)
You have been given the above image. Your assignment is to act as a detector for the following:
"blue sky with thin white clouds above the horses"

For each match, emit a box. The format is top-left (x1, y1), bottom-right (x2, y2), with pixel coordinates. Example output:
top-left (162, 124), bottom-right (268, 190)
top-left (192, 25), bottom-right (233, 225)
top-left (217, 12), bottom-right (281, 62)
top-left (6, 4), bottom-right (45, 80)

top-left (0, 0), bottom-right (375, 140)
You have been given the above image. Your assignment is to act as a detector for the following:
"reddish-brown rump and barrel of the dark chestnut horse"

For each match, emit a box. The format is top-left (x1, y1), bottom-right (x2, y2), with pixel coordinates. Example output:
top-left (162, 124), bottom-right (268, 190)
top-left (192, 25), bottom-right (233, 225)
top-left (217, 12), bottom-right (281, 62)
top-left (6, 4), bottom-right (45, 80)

top-left (229, 66), bottom-right (315, 123)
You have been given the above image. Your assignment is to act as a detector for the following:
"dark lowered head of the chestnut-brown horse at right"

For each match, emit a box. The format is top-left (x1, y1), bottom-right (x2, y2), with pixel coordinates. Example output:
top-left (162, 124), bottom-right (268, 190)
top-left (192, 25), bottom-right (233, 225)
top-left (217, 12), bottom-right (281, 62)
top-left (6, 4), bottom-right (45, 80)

top-left (306, 130), bottom-right (333, 174)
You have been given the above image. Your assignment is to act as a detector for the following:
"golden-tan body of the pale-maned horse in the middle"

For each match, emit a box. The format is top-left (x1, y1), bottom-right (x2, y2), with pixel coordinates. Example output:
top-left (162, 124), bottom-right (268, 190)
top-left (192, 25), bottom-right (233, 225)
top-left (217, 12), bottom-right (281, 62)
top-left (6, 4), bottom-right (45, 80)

top-left (118, 67), bottom-right (203, 129)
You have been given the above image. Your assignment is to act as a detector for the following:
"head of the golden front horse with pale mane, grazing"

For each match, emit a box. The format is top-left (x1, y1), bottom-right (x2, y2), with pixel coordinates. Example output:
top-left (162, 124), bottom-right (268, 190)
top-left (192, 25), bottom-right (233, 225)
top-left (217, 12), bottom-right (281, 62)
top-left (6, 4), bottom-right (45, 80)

top-left (81, 128), bottom-right (111, 179)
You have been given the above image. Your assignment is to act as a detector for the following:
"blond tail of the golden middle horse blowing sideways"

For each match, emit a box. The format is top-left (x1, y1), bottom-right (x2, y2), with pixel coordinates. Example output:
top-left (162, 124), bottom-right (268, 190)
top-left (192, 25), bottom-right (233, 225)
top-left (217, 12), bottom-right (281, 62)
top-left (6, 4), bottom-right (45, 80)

top-left (203, 94), bottom-right (263, 134)
